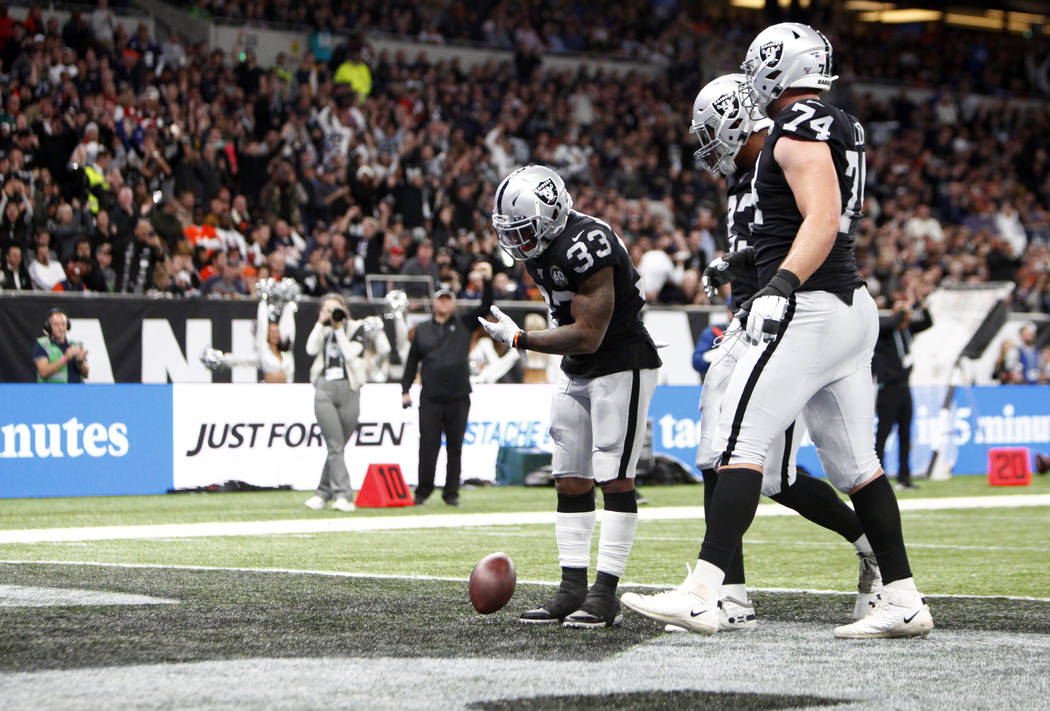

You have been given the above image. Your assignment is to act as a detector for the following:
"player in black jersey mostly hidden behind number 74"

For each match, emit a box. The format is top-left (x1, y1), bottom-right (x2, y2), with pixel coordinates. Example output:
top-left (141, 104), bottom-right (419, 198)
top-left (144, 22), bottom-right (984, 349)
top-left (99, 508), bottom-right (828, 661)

top-left (646, 74), bottom-right (882, 631)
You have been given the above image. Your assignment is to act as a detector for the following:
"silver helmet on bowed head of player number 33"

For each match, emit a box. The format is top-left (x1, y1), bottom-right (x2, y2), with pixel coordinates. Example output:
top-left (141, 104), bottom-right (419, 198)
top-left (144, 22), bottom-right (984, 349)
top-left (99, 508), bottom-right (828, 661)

top-left (492, 165), bottom-right (572, 260)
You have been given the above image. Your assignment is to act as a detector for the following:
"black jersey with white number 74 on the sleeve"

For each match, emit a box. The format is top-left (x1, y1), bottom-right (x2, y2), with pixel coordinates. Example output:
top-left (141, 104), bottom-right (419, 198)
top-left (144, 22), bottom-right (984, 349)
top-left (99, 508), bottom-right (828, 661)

top-left (751, 99), bottom-right (864, 294)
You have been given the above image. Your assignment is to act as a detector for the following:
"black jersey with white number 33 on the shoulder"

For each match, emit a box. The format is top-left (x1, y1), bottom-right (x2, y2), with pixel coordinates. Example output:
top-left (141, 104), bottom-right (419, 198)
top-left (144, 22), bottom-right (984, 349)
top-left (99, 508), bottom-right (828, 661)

top-left (525, 211), bottom-right (662, 378)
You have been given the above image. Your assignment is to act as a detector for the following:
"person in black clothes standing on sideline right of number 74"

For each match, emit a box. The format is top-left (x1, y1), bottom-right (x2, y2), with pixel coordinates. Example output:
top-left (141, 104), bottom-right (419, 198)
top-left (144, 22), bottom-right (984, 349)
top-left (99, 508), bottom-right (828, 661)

top-left (872, 291), bottom-right (933, 488)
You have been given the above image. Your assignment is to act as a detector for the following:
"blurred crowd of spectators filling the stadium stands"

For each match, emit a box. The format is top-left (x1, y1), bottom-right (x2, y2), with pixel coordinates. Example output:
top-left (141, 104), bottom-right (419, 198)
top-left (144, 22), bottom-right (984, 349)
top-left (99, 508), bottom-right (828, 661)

top-left (0, 0), bottom-right (1050, 380)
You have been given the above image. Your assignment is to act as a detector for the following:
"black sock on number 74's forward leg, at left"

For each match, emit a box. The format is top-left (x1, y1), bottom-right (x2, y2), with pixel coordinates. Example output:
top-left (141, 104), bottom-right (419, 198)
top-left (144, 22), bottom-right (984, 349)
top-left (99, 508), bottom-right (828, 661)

top-left (699, 467), bottom-right (762, 572)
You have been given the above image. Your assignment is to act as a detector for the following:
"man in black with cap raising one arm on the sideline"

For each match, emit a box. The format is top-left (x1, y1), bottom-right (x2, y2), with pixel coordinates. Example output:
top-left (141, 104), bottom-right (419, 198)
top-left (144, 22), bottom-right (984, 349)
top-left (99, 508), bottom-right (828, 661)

top-left (401, 263), bottom-right (492, 506)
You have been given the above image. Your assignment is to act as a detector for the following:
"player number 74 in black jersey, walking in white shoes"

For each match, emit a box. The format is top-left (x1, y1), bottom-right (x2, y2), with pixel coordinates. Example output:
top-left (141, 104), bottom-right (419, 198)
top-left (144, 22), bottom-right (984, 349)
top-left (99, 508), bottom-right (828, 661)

top-left (625, 22), bottom-right (933, 639)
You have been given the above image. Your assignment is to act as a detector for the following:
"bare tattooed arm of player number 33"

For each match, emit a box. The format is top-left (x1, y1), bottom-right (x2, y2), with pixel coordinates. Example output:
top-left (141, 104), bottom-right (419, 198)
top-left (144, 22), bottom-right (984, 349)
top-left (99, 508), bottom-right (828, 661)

top-left (528, 267), bottom-right (615, 355)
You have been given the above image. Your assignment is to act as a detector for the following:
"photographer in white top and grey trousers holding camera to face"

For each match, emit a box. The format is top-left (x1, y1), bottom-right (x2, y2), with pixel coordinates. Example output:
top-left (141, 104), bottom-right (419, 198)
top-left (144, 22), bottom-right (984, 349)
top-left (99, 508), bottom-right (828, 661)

top-left (307, 293), bottom-right (368, 511)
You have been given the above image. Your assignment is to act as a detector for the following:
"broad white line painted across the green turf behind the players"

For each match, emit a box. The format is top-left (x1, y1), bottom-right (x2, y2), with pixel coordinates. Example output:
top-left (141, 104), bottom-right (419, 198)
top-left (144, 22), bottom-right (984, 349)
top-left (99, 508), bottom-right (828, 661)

top-left (0, 494), bottom-right (1050, 545)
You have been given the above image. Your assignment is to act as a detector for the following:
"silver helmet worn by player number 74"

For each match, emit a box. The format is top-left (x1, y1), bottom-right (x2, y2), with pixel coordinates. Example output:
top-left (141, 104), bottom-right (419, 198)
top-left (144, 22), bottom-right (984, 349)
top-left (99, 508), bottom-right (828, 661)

top-left (740, 22), bottom-right (838, 116)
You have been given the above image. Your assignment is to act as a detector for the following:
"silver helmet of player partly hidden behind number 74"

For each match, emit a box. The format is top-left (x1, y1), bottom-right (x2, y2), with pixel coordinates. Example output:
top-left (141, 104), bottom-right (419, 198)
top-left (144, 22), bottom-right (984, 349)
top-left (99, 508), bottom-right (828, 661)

top-left (689, 74), bottom-right (773, 175)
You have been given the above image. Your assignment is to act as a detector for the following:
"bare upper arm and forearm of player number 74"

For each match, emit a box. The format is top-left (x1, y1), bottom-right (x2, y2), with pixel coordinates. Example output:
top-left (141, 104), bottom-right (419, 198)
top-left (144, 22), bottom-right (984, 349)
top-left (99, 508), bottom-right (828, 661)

top-left (773, 137), bottom-right (842, 284)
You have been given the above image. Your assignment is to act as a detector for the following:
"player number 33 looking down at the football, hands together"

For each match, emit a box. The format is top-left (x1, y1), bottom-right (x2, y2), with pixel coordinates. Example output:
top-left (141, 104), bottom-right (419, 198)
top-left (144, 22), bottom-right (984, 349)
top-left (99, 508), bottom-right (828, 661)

top-left (479, 165), bottom-right (660, 628)
